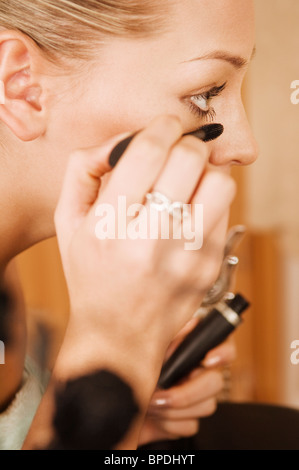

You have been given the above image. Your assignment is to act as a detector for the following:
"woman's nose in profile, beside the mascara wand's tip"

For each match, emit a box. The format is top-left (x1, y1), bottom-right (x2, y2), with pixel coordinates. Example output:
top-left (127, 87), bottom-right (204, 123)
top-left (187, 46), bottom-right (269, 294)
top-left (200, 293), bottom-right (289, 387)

top-left (210, 105), bottom-right (258, 166)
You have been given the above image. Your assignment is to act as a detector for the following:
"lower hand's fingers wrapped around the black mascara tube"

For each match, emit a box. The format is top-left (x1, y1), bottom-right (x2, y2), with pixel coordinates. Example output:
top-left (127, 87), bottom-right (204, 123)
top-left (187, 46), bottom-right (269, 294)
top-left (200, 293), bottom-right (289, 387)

top-left (139, 336), bottom-right (236, 446)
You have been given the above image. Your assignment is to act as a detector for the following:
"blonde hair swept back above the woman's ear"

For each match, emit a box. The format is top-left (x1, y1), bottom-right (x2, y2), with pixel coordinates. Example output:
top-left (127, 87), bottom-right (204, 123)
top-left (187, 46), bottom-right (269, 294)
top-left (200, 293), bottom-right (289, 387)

top-left (0, 0), bottom-right (168, 59)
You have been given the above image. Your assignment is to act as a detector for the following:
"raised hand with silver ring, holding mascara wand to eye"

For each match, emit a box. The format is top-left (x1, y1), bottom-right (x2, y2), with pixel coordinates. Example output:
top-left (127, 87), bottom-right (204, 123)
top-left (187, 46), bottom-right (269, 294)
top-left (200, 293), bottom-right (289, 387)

top-left (55, 116), bottom-right (235, 448)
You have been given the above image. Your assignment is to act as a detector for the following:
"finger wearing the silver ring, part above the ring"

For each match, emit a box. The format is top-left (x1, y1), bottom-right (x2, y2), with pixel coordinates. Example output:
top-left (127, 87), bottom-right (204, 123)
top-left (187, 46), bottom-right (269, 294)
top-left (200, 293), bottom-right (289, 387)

top-left (154, 136), bottom-right (209, 203)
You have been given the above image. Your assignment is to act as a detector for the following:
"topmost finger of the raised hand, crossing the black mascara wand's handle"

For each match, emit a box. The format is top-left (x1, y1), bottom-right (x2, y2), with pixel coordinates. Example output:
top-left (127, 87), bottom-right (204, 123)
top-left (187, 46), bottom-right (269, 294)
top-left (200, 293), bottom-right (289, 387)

top-left (100, 116), bottom-right (183, 205)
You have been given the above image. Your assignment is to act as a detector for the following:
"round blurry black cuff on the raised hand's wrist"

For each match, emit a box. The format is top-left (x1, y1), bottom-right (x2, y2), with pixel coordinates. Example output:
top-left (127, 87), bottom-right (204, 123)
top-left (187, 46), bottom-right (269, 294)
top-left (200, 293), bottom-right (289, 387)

top-left (48, 370), bottom-right (139, 450)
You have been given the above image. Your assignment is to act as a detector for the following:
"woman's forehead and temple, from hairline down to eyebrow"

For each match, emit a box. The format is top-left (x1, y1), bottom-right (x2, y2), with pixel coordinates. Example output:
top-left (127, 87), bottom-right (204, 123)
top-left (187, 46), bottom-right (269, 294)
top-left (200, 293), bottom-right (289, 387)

top-left (98, 0), bottom-right (255, 78)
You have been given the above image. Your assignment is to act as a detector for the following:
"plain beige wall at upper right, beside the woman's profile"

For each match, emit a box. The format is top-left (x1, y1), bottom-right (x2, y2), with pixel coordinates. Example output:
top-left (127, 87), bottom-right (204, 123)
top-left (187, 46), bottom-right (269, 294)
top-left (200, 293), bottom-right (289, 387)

top-left (247, 0), bottom-right (299, 235)
